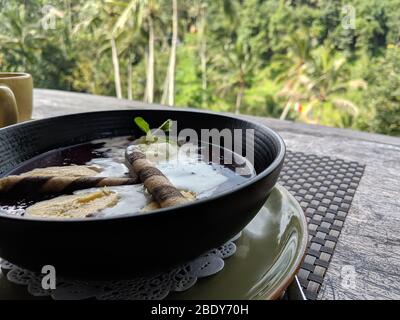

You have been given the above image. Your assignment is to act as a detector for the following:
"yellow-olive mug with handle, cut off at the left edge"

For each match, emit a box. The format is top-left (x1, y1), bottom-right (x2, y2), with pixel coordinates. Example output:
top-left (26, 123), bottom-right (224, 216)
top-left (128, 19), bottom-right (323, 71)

top-left (0, 72), bottom-right (33, 128)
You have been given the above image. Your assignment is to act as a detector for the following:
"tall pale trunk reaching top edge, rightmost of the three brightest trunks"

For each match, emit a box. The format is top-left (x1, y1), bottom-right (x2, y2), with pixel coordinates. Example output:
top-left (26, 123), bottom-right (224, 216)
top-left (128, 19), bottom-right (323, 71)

top-left (161, 0), bottom-right (178, 106)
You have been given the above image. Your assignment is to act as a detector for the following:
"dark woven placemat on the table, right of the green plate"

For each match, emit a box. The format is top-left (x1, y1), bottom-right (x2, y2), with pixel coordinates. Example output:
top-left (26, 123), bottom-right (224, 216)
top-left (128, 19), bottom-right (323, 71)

top-left (279, 151), bottom-right (365, 300)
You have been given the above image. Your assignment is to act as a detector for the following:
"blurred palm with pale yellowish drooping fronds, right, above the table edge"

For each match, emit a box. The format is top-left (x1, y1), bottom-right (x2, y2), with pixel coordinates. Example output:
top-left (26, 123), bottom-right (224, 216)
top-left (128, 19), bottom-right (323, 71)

top-left (276, 31), bottom-right (365, 123)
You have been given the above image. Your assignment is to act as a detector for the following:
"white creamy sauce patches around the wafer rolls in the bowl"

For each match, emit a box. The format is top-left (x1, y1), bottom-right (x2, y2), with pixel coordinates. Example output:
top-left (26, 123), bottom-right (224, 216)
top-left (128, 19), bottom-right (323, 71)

top-left (75, 137), bottom-right (241, 216)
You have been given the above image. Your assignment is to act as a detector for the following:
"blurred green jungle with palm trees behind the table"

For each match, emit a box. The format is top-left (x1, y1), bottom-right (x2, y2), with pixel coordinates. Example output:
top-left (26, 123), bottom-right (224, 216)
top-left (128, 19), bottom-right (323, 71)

top-left (0, 0), bottom-right (400, 135)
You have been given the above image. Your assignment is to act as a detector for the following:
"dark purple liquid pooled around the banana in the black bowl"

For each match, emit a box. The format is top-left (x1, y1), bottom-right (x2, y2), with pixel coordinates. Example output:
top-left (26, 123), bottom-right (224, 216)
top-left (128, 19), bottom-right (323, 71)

top-left (0, 137), bottom-right (255, 215)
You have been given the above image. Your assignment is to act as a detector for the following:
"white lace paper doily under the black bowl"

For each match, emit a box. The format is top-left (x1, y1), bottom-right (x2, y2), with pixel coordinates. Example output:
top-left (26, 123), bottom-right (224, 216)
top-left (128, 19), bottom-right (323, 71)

top-left (0, 234), bottom-right (240, 300)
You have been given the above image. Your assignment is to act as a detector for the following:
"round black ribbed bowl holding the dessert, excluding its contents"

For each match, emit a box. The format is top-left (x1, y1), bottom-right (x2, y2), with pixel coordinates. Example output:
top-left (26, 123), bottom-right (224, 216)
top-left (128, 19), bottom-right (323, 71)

top-left (0, 109), bottom-right (285, 277)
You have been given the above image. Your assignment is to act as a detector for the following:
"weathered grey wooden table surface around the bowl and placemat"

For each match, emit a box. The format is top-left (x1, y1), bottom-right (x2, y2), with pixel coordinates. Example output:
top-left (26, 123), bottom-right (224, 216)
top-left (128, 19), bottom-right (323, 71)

top-left (28, 89), bottom-right (400, 299)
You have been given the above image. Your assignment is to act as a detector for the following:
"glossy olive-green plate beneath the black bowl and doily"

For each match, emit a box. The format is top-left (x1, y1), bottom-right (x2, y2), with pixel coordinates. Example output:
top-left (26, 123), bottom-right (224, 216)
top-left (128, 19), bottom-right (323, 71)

top-left (170, 185), bottom-right (308, 299)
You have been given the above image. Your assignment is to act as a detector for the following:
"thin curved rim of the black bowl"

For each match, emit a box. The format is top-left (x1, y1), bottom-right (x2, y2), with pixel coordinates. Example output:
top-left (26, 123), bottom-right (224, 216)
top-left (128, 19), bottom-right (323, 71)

top-left (0, 107), bottom-right (286, 224)
